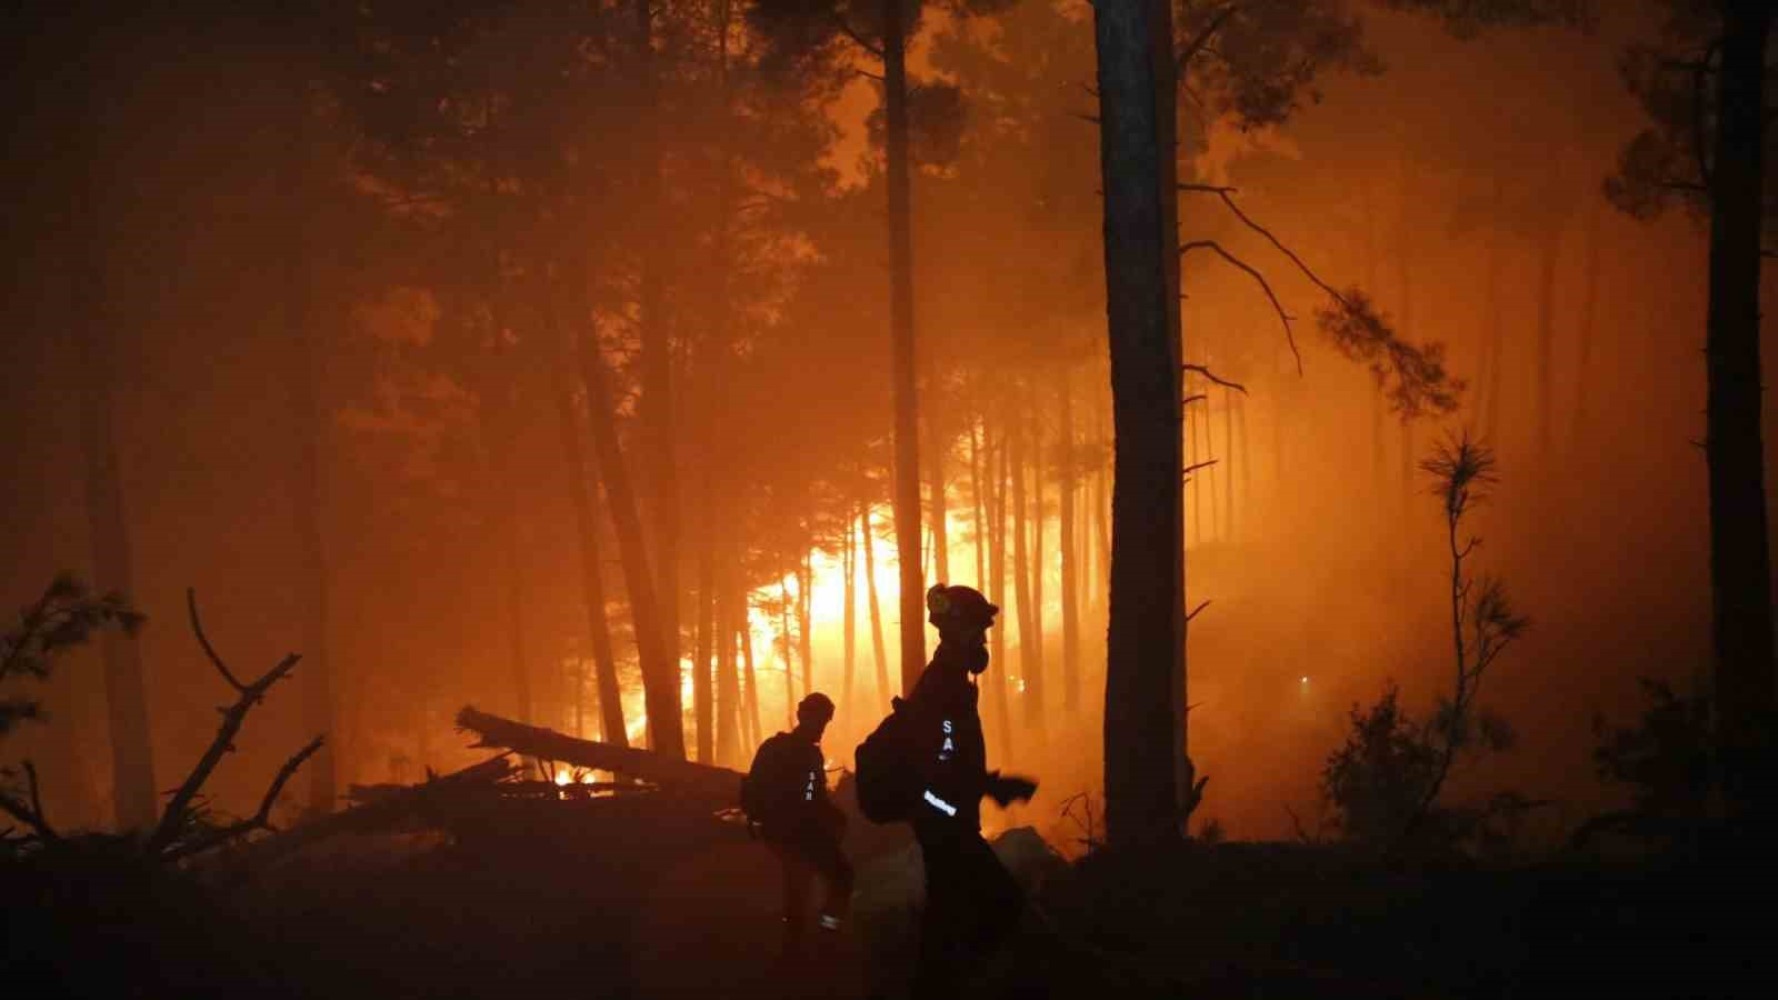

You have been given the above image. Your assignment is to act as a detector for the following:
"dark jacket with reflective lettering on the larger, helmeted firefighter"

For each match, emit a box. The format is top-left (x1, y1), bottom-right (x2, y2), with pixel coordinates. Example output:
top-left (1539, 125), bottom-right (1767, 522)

top-left (909, 642), bottom-right (989, 831)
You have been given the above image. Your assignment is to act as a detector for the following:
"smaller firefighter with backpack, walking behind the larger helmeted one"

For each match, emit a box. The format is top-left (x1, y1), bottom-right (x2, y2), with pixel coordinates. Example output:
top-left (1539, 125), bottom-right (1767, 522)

top-left (741, 692), bottom-right (852, 957)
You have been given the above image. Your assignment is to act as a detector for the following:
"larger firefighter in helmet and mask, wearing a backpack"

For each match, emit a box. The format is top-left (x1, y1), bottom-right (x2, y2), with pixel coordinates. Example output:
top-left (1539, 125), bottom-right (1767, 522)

top-left (857, 584), bottom-right (1037, 1000)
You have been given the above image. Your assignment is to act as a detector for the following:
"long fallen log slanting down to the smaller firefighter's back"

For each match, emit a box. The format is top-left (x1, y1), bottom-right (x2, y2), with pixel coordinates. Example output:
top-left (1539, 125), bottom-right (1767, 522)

top-left (457, 705), bottom-right (741, 811)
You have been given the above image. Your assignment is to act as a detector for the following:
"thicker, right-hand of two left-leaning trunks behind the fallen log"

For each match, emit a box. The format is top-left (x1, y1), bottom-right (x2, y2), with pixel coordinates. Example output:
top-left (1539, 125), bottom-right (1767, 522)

top-left (580, 327), bottom-right (685, 760)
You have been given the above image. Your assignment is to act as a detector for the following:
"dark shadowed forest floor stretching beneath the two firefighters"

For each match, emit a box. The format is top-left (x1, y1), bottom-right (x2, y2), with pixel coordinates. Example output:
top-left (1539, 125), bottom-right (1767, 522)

top-left (0, 799), bottom-right (1778, 1000)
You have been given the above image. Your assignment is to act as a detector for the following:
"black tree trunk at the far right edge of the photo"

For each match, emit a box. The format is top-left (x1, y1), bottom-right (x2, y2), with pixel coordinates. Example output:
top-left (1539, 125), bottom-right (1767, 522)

top-left (1705, 0), bottom-right (1774, 813)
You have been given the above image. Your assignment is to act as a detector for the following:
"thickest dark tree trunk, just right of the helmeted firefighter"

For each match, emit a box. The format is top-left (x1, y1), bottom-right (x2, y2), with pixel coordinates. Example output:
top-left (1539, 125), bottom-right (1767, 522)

top-left (1093, 0), bottom-right (1186, 847)
